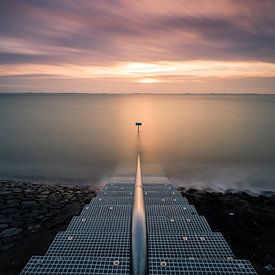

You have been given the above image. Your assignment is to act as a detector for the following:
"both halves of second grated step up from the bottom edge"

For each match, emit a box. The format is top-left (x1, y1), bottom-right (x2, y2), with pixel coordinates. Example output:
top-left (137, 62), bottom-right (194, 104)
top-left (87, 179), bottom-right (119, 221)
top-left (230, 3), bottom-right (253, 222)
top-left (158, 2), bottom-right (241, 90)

top-left (46, 232), bottom-right (234, 260)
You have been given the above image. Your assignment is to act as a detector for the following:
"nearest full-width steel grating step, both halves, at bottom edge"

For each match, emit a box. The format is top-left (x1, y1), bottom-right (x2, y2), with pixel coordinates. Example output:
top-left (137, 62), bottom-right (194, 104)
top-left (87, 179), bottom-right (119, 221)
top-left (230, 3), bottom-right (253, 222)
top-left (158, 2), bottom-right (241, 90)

top-left (21, 256), bottom-right (257, 275)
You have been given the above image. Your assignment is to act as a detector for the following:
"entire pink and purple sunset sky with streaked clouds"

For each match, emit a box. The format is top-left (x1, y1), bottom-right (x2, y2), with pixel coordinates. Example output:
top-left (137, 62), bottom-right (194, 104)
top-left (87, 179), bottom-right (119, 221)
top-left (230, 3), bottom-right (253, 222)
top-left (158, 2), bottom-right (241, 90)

top-left (0, 0), bottom-right (275, 93)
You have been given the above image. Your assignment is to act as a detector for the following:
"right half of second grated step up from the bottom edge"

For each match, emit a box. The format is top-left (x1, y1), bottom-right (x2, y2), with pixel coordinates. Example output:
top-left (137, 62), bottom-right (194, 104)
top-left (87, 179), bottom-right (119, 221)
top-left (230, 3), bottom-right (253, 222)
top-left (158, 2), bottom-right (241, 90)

top-left (148, 233), bottom-right (234, 260)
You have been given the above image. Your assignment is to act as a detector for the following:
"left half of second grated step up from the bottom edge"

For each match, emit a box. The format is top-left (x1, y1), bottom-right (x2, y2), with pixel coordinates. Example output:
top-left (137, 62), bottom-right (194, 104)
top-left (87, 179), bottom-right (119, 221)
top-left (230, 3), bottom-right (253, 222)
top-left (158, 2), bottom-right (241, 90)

top-left (46, 232), bottom-right (130, 257)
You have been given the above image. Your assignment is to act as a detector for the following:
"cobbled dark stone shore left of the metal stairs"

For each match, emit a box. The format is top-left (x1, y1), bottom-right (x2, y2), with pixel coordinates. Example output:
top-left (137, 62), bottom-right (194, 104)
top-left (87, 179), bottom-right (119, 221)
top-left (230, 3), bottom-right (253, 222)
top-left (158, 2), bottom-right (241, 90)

top-left (0, 180), bottom-right (95, 275)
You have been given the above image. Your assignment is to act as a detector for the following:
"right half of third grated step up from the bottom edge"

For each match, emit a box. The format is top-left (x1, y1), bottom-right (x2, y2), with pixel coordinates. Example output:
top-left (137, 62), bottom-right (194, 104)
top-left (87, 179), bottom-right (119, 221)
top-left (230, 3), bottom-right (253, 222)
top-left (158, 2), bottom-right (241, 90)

top-left (147, 215), bottom-right (211, 234)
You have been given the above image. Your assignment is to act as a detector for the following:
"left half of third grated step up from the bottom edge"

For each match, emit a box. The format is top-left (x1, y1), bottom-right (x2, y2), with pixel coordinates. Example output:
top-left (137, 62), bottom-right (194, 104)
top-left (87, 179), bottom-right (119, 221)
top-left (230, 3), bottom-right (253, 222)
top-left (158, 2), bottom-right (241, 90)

top-left (67, 216), bottom-right (131, 232)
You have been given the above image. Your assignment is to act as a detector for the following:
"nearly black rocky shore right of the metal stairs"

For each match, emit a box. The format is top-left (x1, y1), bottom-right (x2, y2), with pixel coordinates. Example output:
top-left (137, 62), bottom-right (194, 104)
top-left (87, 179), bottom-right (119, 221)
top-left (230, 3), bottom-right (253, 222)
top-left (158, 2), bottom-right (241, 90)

top-left (180, 188), bottom-right (275, 275)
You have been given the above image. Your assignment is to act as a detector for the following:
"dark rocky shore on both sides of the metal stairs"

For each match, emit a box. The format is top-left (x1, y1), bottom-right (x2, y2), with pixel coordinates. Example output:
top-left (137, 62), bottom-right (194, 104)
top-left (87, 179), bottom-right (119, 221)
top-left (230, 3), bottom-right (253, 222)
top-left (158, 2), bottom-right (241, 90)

top-left (0, 180), bottom-right (275, 275)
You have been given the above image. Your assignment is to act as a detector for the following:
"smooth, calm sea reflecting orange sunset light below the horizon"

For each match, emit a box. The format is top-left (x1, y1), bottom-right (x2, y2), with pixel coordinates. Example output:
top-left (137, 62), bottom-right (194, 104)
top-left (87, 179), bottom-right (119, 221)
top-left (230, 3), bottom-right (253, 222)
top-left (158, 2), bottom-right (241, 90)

top-left (0, 94), bottom-right (275, 196)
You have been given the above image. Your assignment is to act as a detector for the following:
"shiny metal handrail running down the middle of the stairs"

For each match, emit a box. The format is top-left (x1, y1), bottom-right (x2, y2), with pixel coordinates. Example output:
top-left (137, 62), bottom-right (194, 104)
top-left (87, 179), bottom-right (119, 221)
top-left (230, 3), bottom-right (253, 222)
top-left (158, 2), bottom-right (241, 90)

top-left (130, 152), bottom-right (148, 275)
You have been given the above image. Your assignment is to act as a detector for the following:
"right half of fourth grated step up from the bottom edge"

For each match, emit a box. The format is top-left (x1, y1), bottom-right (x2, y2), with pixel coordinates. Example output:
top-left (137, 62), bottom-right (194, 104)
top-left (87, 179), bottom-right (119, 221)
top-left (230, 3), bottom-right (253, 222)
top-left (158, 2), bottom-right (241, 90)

top-left (146, 205), bottom-right (198, 217)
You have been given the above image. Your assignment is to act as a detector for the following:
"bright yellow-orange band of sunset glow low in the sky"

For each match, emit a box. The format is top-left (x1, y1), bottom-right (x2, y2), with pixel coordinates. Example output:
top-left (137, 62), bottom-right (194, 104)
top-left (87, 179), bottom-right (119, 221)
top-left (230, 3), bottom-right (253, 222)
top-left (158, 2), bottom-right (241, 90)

top-left (0, 60), bottom-right (275, 84)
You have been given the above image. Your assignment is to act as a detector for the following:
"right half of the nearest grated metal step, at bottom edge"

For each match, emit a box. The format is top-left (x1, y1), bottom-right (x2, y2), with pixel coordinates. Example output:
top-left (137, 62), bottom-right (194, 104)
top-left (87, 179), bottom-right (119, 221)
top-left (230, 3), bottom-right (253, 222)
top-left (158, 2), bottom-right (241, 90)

top-left (149, 258), bottom-right (257, 275)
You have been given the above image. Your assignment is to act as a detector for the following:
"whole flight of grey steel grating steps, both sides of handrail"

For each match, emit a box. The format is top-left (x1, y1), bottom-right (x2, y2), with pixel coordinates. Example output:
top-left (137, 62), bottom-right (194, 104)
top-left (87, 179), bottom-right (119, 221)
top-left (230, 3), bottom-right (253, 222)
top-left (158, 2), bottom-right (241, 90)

top-left (21, 178), bottom-right (256, 275)
